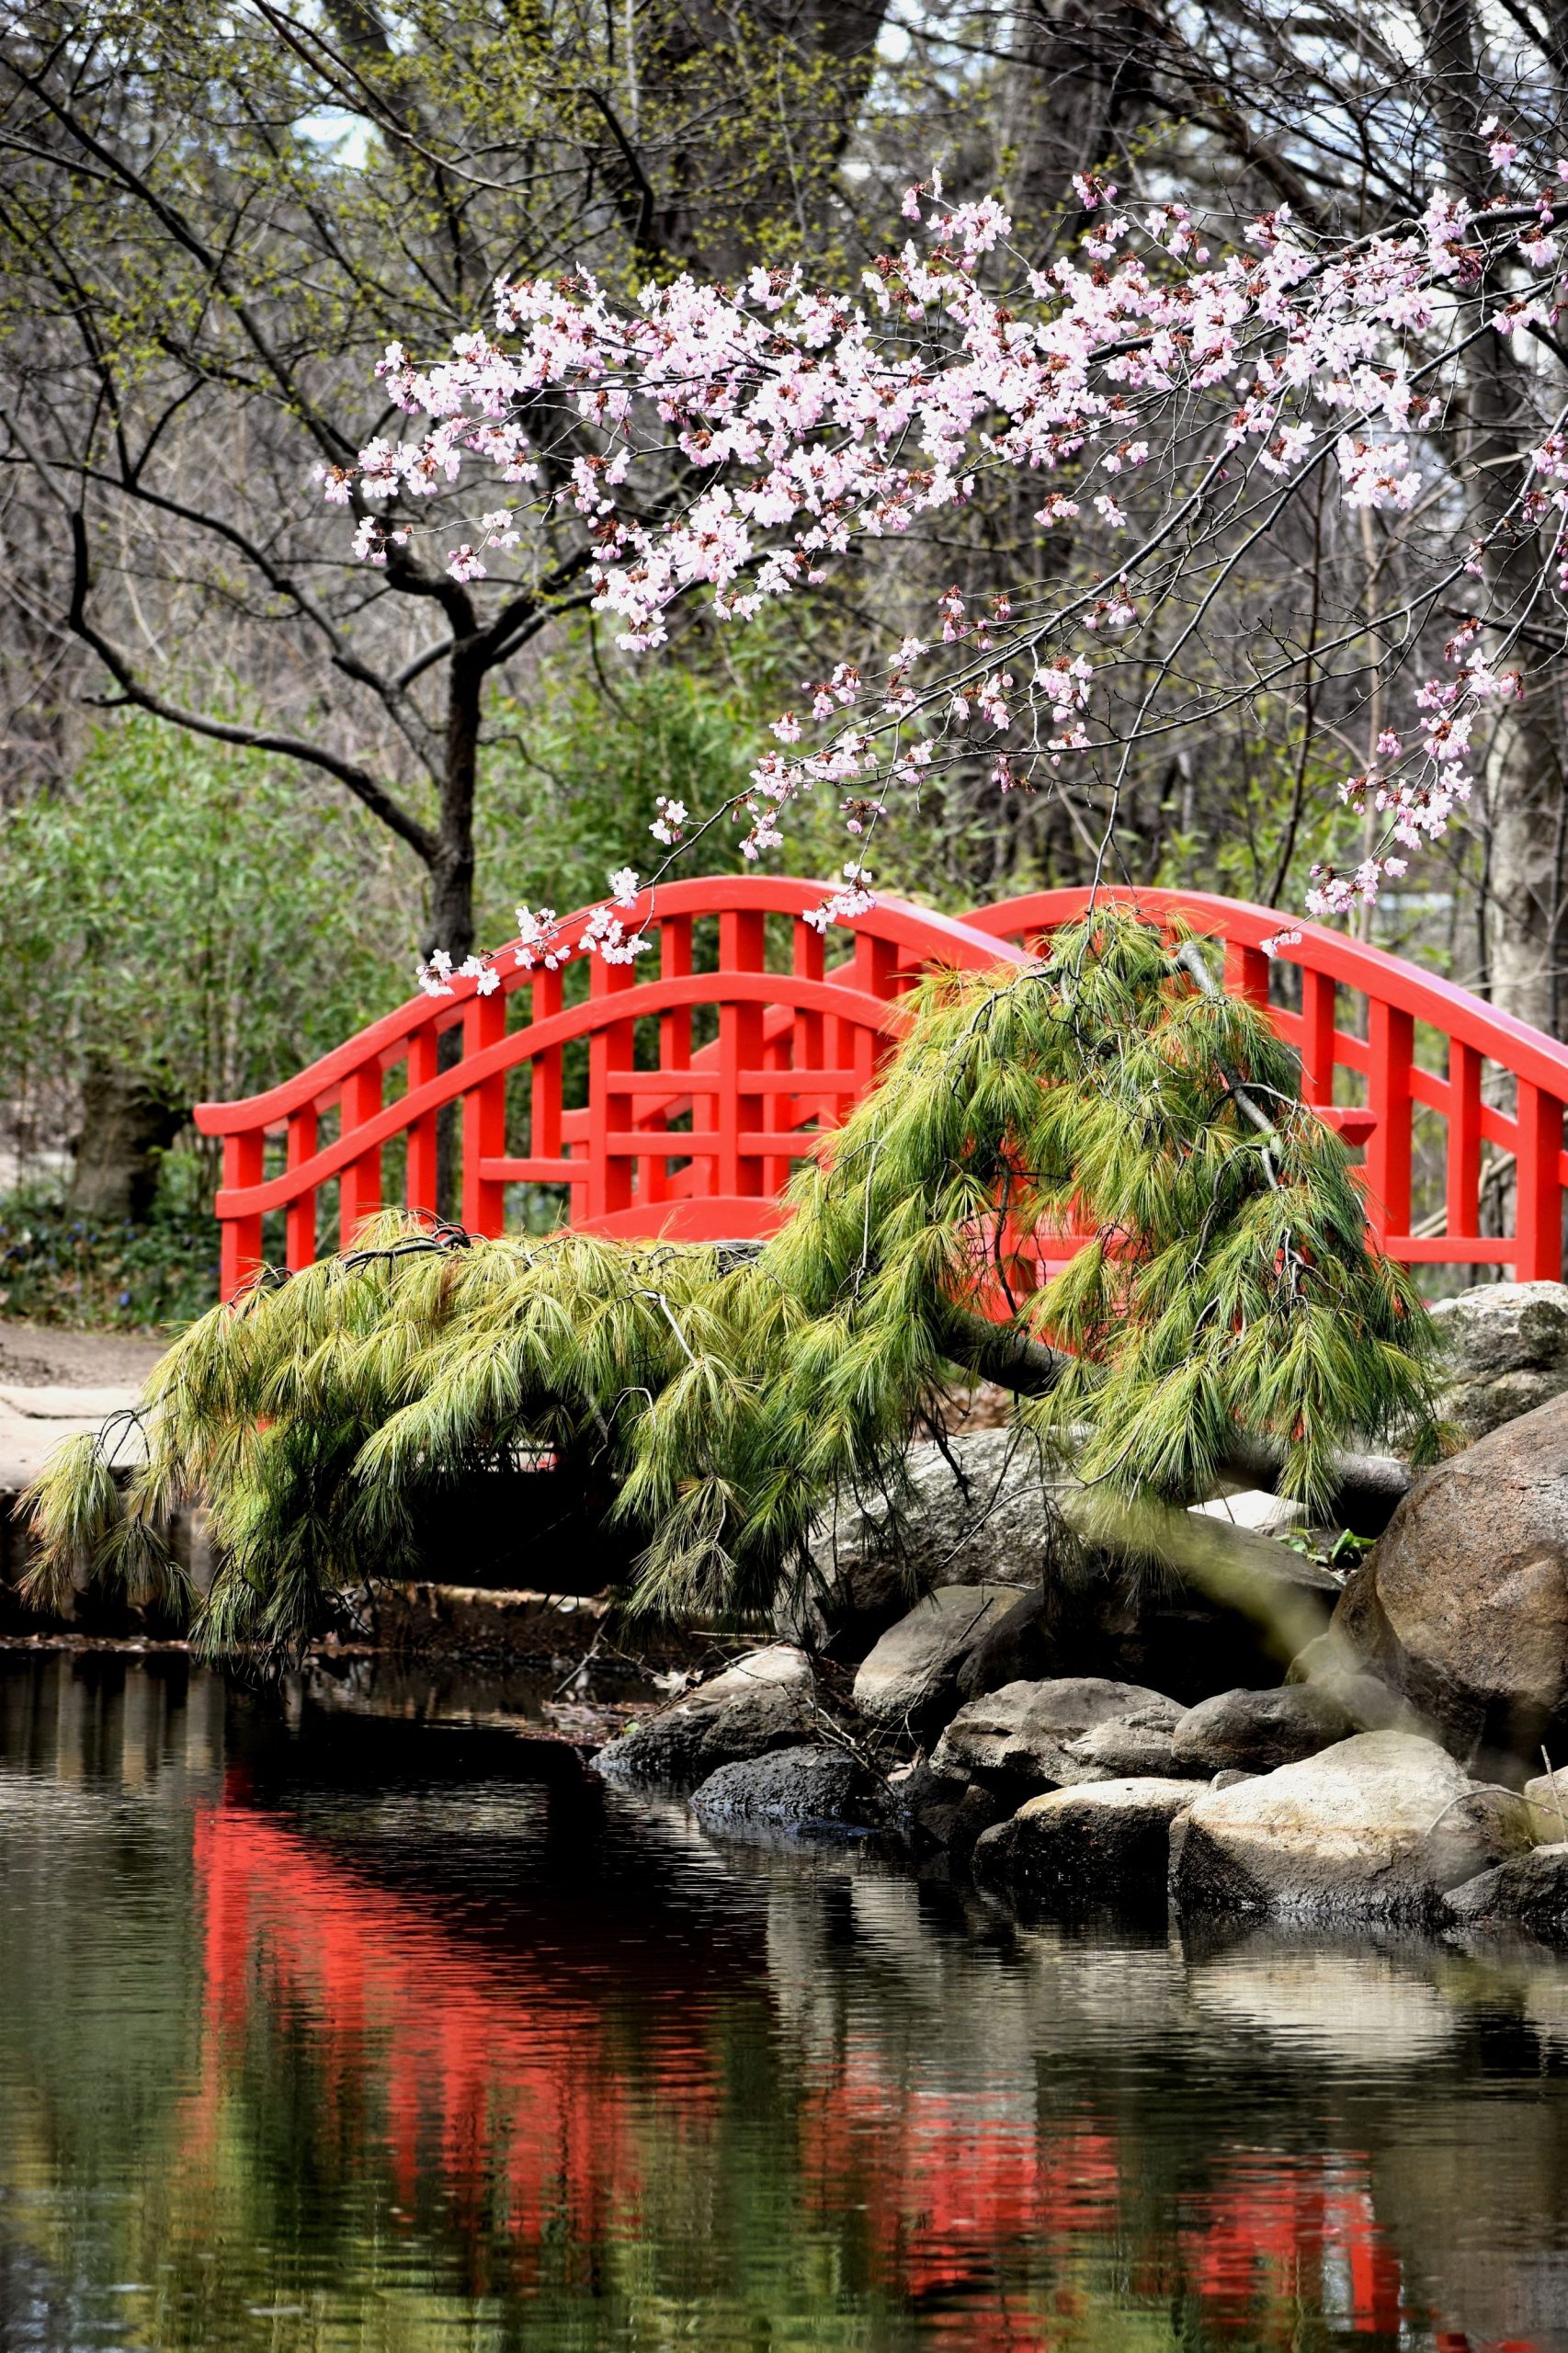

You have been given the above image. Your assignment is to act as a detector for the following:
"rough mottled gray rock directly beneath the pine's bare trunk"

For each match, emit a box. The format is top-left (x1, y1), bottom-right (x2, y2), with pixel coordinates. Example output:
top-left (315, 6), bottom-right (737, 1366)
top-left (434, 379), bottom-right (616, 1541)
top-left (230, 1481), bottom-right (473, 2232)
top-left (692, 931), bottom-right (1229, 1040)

top-left (775, 1430), bottom-right (1072, 1656)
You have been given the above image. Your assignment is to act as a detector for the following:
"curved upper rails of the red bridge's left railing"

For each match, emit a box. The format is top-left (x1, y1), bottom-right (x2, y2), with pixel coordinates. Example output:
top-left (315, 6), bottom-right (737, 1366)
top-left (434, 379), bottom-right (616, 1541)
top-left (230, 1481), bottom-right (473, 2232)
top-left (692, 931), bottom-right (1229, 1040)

top-left (193, 875), bottom-right (1028, 1143)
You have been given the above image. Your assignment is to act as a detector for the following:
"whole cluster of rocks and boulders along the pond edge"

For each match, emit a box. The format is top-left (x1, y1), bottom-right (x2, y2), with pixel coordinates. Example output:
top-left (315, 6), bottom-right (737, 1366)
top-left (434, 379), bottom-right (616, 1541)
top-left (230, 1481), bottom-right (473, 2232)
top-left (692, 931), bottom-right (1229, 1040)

top-left (600, 1285), bottom-right (1568, 1941)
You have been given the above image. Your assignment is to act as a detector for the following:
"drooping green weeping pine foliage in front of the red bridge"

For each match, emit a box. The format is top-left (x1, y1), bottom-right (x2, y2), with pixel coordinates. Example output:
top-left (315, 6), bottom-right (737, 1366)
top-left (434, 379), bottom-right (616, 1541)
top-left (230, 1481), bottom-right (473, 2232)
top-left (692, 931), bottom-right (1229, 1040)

top-left (33, 913), bottom-right (1434, 1650)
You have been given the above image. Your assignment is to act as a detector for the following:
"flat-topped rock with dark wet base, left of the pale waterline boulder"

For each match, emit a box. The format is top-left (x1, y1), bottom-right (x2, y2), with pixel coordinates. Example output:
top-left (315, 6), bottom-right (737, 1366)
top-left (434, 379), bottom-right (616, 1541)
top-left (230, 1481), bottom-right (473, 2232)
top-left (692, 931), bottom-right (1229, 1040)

top-left (974, 1777), bottom-right (1200, 1904)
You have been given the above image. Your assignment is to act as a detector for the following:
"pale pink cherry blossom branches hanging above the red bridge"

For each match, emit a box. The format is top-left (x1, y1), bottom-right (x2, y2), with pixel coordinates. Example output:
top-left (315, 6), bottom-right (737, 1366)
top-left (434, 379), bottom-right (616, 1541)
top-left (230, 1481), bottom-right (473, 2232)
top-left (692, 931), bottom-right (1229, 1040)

top-left (324, 149), bottom-right (1568, 982)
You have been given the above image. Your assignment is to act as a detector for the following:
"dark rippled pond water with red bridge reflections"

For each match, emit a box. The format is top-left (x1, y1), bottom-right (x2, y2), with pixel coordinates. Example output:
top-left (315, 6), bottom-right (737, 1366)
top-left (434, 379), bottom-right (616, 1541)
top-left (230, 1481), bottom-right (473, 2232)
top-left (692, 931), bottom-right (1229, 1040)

top-left (0, 1654), bottom-right (1568, 2353)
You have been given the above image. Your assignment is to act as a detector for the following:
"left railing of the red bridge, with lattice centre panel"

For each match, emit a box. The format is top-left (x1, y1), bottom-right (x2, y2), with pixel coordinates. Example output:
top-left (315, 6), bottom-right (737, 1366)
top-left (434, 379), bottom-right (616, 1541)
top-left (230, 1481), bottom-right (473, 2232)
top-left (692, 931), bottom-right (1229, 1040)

top-left (196, 875), bottom-right (1027, 1297)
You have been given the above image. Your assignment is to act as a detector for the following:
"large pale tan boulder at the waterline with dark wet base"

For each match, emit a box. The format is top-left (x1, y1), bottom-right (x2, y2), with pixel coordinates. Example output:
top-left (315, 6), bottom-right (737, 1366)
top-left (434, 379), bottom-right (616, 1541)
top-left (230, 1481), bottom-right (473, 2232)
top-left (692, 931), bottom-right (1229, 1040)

top-left (1170, 1732), bottom-right (1533, 1920)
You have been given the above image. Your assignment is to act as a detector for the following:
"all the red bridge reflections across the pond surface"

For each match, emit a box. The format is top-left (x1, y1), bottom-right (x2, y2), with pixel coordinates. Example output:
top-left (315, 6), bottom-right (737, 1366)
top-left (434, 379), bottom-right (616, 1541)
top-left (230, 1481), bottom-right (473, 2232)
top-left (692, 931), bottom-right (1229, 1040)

top-left (188, 1798), bottom-right (1533, 2353)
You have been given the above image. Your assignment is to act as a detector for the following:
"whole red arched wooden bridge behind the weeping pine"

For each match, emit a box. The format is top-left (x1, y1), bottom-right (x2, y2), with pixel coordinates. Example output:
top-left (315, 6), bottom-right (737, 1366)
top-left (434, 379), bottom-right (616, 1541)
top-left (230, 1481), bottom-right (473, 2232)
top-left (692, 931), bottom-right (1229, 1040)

top-left (196, 875), bottom-right (1568, 1297)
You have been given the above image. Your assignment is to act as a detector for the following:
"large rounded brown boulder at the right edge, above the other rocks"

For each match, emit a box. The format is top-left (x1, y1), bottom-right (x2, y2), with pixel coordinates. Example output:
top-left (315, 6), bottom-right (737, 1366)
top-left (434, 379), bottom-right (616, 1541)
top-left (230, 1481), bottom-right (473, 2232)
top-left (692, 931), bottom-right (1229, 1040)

top-left (1333, 1395), bottom-right (1568, 1757)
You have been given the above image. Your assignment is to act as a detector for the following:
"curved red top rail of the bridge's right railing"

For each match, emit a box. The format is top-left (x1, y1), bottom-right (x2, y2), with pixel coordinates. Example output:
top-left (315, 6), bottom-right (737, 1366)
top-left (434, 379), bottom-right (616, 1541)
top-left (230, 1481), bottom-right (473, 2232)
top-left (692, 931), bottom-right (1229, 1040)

top-left (963, 887), bottom-right (1568, 1101)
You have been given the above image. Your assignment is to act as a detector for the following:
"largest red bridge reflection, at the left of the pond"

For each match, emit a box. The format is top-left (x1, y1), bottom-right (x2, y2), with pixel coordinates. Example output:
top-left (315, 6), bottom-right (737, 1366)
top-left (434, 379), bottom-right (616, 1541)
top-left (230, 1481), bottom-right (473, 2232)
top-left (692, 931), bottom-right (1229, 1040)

top-left (193, 1802), bottom-right (713, 2268)
